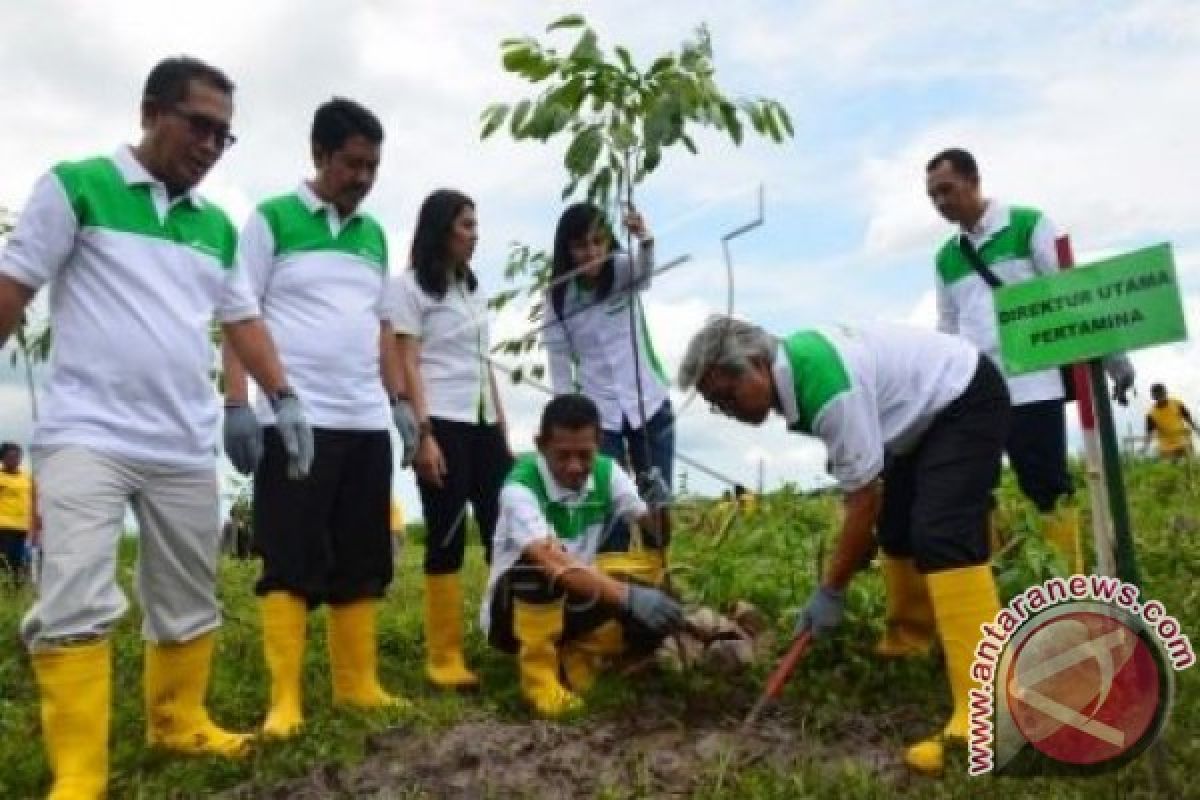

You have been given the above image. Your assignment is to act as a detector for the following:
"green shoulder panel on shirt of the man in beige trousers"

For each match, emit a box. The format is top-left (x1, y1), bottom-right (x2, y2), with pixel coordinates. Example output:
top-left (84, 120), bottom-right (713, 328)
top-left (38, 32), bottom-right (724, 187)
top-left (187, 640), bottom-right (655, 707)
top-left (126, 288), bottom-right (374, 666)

top-left (53, 156), bottom-right (238, 270)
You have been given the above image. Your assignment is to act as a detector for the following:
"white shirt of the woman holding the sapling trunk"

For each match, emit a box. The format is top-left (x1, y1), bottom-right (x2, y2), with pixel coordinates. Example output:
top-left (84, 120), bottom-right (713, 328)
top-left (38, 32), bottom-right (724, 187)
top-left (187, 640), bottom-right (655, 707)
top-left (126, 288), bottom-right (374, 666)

top-left (541, 242), bottom-right (670, 432)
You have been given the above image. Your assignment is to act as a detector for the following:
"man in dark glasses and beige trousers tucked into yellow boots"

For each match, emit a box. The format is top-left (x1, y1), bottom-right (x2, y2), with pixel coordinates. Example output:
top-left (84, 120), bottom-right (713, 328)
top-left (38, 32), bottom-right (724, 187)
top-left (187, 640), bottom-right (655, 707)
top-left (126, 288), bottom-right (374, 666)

top-left (0, 56), bottom-right (312, 798)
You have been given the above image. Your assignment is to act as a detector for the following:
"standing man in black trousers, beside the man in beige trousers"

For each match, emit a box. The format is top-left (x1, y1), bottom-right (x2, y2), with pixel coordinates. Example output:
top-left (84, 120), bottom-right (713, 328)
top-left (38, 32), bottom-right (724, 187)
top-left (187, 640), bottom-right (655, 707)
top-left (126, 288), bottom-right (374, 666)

top-left (226, 97), bottom-right (416, 736)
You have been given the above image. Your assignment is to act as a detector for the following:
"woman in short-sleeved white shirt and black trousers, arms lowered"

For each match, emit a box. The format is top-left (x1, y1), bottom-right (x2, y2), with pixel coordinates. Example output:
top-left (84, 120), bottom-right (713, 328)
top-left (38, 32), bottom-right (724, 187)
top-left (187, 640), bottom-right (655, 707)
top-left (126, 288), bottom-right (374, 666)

top-left (389, 190), bottom-right (512, 688)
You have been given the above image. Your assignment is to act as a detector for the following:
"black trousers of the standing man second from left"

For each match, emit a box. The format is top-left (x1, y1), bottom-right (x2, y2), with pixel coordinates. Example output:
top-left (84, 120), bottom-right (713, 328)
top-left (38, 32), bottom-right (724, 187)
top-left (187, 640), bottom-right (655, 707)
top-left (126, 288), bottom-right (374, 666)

top-left (254, 426), bottom-right (392, 607)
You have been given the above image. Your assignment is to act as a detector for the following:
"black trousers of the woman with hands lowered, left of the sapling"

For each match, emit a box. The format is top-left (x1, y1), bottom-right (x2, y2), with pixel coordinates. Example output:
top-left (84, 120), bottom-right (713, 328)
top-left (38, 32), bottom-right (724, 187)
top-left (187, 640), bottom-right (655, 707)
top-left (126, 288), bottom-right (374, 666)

top-left (416, 417), bottom-right (512, 575)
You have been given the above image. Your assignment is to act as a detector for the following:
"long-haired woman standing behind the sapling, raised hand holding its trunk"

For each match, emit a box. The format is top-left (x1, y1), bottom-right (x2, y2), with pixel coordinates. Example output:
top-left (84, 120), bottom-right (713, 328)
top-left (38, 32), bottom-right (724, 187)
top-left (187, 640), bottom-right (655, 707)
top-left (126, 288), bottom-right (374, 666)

top-left (542, 203), bottom-right (674, 584)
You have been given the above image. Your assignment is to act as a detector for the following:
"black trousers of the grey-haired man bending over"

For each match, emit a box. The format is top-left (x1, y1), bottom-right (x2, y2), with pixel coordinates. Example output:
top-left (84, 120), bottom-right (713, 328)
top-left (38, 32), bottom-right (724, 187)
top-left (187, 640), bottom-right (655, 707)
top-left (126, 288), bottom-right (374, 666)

top-left (876, 357), bottom-right (1012, 573)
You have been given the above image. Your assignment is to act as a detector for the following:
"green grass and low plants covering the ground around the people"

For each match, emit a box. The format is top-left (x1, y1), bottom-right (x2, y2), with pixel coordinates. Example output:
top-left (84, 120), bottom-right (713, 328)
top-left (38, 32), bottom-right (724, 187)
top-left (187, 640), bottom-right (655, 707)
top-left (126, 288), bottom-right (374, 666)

top-left (0, 464), bottom-right (1200, 798)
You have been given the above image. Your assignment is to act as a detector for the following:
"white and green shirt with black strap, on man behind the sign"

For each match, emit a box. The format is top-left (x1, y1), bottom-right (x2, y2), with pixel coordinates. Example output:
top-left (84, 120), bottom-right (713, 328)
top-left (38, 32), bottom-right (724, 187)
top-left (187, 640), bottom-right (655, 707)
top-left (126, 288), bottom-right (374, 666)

top-left (937, 200), bottom-right (1063, 405)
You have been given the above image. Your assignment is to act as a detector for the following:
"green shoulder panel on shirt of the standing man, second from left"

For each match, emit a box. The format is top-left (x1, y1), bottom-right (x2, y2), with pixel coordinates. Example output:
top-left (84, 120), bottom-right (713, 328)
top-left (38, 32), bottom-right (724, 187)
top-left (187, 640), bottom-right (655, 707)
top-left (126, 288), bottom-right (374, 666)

top-left (258, 192), bottom-right (388, 273)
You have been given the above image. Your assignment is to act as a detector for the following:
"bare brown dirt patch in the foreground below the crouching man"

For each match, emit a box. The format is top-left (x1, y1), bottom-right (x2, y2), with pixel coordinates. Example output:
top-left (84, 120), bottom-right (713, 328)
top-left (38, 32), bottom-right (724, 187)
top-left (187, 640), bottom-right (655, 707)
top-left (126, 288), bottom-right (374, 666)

top-left (224, 712), bottom-right (904, 800)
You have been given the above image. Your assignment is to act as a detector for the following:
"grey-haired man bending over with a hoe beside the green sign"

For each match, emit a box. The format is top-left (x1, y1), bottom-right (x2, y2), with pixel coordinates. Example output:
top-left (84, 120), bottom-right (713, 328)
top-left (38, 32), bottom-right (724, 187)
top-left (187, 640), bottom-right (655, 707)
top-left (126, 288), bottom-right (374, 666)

top-left (679, 317), bottom-right (1010, 772)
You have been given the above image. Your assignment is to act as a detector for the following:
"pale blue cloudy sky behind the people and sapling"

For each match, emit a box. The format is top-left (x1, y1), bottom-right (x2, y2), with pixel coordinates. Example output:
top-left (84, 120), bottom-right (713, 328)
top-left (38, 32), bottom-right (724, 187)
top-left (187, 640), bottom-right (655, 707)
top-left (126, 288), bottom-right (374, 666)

top-left (0, 0), bottom-right (1200, 513)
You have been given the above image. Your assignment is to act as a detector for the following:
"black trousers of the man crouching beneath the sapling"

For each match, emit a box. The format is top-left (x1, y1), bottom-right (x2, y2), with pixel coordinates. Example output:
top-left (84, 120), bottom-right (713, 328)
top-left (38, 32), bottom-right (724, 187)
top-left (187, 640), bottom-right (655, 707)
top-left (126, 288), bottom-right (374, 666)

top-left (487, 558), bottom-right (662, 654)
